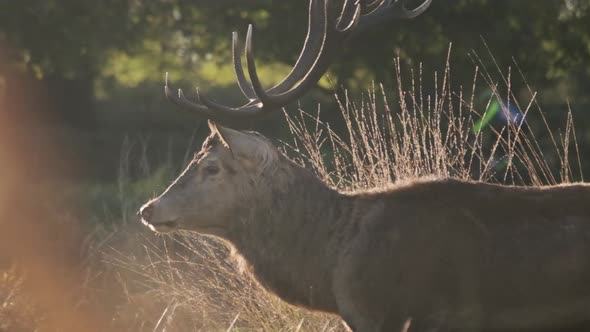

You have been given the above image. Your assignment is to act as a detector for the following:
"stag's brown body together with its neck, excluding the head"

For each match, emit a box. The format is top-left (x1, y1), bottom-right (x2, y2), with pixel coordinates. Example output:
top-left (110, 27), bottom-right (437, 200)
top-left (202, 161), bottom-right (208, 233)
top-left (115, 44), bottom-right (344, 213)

top-left (230, 171), bottom-right (590, 331)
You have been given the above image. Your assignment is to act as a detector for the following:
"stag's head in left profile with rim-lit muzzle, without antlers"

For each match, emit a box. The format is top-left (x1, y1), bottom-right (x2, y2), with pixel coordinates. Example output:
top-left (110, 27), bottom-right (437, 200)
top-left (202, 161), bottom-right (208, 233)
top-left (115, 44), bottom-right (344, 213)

top-left (141, 121), bottom-right (280, 236)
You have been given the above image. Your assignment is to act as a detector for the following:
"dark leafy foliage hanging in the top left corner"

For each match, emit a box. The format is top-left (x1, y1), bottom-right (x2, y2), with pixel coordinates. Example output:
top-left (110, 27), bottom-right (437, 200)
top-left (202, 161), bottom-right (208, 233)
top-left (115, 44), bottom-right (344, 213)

top-left (0, 0), bottom-right (135, 78)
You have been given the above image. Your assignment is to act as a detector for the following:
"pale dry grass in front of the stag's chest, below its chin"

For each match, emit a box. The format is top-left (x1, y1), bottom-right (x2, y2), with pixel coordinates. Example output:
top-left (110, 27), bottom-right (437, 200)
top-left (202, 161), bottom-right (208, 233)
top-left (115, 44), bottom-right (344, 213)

top-left (105, 228), bottom-right (341, 331)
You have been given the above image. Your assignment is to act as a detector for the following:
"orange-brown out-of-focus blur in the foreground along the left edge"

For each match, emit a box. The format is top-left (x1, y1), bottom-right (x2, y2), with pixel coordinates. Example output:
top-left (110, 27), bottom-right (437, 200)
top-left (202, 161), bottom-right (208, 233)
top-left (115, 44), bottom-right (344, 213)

top-left (0, 41), bottom-right (117, 332)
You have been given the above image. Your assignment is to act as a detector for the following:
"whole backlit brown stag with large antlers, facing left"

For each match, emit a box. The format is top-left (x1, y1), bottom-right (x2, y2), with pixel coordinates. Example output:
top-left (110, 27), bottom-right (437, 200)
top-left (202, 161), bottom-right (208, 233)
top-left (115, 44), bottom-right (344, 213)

top-left (140, 0), bottom-right (590, 332)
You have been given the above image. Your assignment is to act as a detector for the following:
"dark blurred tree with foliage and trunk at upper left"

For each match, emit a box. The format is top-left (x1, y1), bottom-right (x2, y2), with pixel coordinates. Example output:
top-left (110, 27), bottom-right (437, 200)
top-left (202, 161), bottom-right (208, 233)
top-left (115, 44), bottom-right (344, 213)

top-left (0, 0), bottom-right (135, 124)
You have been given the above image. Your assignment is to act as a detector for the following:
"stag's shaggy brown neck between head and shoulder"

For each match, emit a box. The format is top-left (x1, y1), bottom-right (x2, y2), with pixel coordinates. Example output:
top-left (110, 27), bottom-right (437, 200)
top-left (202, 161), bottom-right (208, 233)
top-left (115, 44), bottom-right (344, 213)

top-left (230, 160), bottom-right (352, 312)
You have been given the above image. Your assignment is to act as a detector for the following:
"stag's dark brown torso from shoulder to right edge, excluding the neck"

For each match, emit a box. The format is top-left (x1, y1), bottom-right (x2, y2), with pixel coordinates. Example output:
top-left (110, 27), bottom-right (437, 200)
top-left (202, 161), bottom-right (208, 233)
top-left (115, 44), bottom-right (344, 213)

top-left (334, 179), bottom-right (590, 331)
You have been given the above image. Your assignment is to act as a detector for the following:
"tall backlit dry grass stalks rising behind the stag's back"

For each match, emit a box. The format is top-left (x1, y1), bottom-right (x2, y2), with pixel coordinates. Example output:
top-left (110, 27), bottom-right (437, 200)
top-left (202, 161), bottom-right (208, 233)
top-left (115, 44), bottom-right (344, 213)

top-left (286, 50), bottom-right (583, 190)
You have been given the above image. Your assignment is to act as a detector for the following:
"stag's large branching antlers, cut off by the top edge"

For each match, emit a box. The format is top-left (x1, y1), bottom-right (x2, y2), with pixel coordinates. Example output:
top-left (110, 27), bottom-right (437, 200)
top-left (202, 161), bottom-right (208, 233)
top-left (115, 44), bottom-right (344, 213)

top-left (164, 0), bottom-right (432, 124)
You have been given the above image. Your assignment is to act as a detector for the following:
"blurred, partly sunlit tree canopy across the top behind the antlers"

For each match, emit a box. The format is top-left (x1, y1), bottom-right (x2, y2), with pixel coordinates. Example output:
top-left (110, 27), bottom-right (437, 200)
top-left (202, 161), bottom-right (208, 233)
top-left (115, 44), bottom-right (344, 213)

top-left (0, 0), bottom-right (590, 120)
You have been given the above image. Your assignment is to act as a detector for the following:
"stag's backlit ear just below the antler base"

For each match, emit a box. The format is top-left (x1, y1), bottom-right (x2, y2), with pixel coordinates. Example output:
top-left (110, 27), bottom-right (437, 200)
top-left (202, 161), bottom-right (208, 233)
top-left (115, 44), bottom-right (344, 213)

top-left (209, 121), bottom-right (278, 168)
